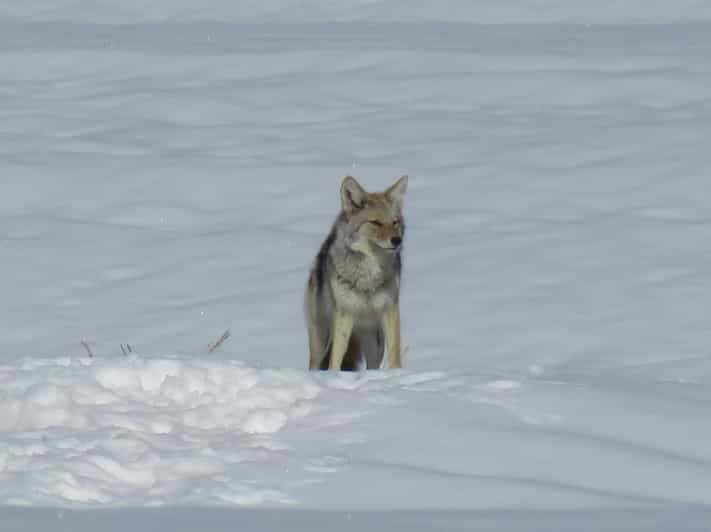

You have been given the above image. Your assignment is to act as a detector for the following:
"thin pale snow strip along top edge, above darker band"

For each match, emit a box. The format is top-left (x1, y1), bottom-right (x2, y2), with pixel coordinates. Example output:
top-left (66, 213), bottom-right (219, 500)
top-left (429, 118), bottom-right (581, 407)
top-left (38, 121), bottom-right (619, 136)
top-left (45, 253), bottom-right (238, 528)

top-left (0, 0), bottom-right (711, 24)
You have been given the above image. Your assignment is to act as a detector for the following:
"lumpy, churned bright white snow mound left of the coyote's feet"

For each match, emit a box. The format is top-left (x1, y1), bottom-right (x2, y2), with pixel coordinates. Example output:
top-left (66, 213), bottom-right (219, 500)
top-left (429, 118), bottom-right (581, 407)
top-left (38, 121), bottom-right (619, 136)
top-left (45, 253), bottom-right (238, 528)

top-left (0, 356), bottom-right (320, 506)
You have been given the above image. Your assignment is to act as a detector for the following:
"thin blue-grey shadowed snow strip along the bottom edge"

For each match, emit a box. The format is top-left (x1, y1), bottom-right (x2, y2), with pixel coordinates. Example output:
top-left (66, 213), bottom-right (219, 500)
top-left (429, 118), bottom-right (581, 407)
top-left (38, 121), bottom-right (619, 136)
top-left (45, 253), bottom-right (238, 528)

top-left (0, 506), bottom-right (711, 532)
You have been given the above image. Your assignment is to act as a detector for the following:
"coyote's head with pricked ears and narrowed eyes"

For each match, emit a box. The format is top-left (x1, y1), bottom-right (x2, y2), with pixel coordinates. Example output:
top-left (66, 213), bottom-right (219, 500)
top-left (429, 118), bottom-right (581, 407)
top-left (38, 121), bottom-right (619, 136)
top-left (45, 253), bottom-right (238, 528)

top-left (341, 176), bottom-right (407, 255)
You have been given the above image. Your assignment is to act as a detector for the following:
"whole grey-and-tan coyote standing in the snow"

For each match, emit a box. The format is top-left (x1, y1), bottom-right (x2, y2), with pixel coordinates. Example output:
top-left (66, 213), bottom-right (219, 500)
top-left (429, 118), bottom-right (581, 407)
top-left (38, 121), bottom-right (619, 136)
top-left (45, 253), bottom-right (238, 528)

top-left (304, 176), bottom-right (407, 371)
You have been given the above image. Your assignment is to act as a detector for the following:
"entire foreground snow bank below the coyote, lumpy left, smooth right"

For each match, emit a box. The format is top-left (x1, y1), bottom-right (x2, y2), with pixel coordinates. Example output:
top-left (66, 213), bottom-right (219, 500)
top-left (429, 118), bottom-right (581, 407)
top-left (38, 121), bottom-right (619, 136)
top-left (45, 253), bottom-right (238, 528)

top-left (0, 354), bottom-right (709, 510)
